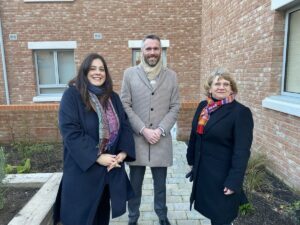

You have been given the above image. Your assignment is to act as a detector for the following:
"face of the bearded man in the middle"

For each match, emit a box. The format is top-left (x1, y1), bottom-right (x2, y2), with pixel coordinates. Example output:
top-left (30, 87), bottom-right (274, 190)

top-left (142, 39), bottom-right (161, 67)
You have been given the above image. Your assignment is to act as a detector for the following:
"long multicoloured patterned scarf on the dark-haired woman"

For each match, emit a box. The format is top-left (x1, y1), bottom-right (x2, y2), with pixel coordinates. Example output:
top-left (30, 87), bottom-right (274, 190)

top-left (88, 85), bottom-right (120, 155)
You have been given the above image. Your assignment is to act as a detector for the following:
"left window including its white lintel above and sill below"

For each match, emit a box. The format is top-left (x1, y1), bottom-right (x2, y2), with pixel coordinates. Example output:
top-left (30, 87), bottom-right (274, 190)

top-left (28, 41), bottom-right (77, 102)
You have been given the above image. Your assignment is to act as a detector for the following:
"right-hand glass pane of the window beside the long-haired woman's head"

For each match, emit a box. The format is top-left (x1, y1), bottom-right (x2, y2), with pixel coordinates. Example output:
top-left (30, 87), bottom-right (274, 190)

top-left (57, 51), bottom-right (75, 84)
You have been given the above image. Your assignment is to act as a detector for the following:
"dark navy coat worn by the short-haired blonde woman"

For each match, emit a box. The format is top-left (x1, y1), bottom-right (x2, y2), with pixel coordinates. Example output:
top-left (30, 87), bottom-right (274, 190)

top-left (187, 101), bottom-right (253, 223)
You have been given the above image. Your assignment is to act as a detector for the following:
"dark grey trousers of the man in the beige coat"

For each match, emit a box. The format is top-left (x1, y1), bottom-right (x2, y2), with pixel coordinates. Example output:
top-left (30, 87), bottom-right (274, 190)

top-left (128, 166), bottom-right (168, 222)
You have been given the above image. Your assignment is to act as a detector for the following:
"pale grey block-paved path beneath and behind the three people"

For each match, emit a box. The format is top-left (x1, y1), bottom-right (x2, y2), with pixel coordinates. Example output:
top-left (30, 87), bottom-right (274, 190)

top-left (110, 141), bottom-right (210, 225)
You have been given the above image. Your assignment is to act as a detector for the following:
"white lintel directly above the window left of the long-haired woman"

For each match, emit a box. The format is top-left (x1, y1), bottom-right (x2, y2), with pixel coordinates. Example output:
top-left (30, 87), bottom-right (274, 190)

top-left (28, 41), bottom-right (77, 49)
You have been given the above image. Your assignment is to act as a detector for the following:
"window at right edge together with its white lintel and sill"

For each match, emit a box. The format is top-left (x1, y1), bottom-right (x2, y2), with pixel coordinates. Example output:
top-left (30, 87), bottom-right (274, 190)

top-left (262, 3), bottom-right (300, 117)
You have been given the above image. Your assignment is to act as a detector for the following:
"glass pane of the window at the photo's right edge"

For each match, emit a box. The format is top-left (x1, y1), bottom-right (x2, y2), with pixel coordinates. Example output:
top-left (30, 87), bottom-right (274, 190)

top-left (285, 10), bottom-right (300, 93)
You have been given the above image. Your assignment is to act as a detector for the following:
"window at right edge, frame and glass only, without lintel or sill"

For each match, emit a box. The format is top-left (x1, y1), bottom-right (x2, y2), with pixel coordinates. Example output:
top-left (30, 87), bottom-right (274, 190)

top-left (282, 7), bottom-right (300, 97)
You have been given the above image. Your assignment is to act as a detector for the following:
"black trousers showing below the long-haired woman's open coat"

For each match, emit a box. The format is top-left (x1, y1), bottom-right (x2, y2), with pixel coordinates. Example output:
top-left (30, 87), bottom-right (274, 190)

top-left (93, 185), bottom-right (110, 225)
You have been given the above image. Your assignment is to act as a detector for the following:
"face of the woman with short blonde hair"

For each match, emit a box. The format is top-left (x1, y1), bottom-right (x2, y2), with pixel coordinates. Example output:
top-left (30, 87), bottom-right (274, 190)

top-left (209, 76), bottom-right (233, 100)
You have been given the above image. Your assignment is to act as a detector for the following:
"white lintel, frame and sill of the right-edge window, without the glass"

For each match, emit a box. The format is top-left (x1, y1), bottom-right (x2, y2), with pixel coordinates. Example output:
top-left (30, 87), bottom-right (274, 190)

top-left (262, 3), bottom-right (300, 117)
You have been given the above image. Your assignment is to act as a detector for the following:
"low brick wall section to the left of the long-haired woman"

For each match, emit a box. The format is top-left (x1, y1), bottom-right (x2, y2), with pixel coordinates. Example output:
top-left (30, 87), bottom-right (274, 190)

top-left (0, 104), bottom-right (61, 143)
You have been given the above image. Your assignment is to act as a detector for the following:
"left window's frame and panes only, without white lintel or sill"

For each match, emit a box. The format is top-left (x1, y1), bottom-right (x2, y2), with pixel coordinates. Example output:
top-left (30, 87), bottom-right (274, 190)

top-left (34, 50), bottom-right (75, 95)
